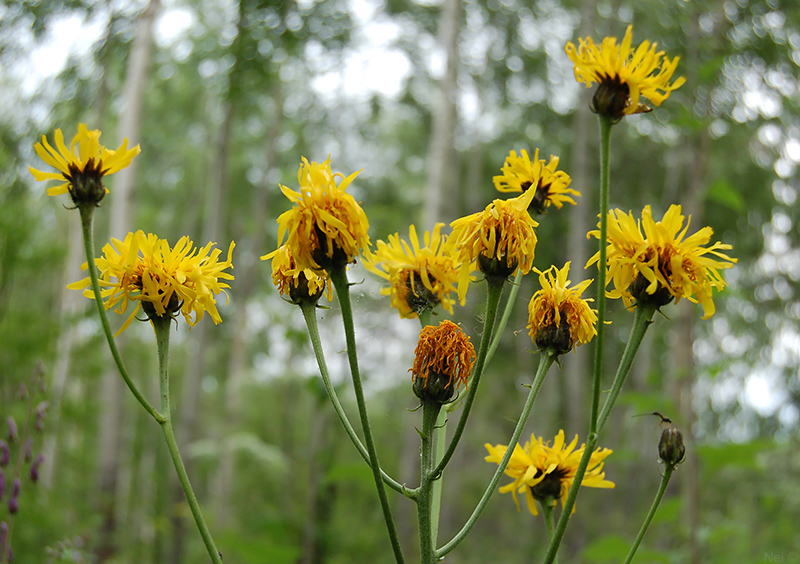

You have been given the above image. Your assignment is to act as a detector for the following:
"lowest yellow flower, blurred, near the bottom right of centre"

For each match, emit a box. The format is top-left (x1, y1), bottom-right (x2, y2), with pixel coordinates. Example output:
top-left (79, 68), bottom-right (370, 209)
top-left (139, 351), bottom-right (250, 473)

top-left (484, 430), bottom-right (614, 515)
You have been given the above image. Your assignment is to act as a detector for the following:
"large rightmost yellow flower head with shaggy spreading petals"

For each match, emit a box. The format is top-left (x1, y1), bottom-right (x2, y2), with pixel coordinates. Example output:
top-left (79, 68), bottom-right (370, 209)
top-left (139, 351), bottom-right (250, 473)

top-left (587, 205), bottom-right (738, 319)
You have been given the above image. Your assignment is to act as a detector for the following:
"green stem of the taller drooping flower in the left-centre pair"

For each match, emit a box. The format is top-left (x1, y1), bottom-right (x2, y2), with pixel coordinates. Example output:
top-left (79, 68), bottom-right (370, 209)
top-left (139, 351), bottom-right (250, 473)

top-left (329, 265), bottom-right (405, 564)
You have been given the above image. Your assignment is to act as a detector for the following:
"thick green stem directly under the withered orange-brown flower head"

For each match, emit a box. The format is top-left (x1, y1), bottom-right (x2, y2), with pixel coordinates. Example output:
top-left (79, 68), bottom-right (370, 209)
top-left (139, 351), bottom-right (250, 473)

top-left (417, 400), bottom-right (441, 564)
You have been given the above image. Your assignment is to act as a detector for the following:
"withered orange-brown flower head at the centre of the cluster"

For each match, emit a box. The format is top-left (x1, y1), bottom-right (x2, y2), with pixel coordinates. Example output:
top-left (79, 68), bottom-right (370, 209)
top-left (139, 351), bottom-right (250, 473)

top-left (409, 320), bottom-right (475, 404)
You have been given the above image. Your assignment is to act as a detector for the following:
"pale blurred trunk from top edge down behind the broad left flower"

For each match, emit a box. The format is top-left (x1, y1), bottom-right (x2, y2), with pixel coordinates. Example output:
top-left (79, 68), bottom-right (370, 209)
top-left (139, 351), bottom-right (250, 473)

top-left (97, 0), bottom-right (160, 562)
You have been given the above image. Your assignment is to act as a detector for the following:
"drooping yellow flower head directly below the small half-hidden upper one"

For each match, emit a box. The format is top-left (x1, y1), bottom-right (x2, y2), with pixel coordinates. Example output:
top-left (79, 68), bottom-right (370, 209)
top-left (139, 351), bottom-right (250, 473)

top-left (447, 190), bottom-right (539, 299)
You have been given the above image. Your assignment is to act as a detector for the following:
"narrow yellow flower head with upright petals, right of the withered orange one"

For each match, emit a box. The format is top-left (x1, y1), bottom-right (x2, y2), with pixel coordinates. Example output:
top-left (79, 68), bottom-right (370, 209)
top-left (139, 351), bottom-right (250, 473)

top-left (528, 262), bottom-right (597, 354)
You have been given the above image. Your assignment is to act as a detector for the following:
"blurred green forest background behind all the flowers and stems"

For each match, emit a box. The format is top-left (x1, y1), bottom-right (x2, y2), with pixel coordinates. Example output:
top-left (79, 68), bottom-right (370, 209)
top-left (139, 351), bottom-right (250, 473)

top-left (0, 0), bottom-right (800, 564)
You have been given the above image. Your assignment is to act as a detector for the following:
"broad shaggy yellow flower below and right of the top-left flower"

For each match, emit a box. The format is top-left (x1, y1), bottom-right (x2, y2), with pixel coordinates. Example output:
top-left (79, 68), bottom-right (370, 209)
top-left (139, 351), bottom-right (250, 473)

top-left (67, 231), bottom-right (235, 335)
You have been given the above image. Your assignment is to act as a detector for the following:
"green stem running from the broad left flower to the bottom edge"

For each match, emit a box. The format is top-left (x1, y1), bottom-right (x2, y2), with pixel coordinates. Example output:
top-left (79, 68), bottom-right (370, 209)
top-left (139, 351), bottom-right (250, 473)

top-left (152, 316), bottom-right (222, 564)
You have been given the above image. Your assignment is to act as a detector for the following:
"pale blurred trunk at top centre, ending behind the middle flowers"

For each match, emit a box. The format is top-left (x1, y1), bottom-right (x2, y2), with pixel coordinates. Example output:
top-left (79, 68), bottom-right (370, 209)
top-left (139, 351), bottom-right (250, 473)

top-left (423, 0), bottom-right (462, 230)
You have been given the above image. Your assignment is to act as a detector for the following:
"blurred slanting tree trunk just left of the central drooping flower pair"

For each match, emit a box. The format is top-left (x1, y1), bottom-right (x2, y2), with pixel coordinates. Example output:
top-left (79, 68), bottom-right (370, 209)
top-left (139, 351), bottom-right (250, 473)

top-left (213, 80), bottom-right (283, 527)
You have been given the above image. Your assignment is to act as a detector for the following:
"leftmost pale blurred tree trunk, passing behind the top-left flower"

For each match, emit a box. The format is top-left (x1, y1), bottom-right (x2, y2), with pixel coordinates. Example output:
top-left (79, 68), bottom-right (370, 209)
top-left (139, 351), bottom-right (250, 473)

top-left (41, 6), bottom-right (118, 489)
